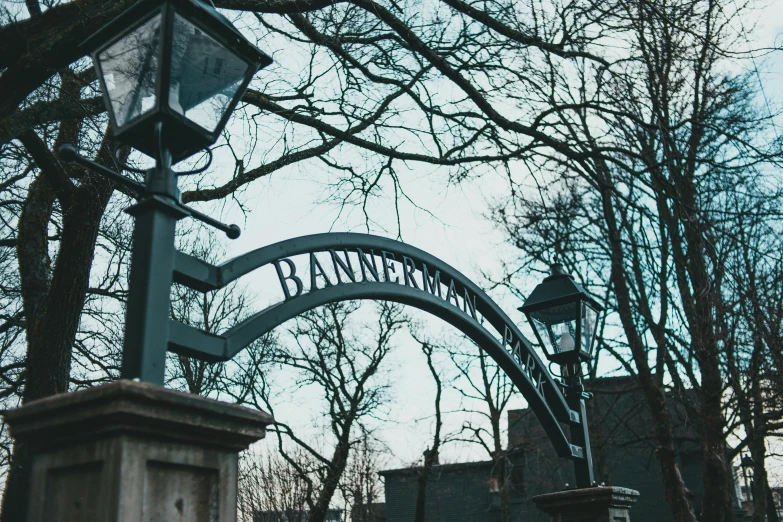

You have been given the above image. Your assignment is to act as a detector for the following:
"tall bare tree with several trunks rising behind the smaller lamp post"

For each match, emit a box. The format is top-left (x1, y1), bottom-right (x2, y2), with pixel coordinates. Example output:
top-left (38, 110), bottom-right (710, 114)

top-left (495, 1), bottom-right (780, 521)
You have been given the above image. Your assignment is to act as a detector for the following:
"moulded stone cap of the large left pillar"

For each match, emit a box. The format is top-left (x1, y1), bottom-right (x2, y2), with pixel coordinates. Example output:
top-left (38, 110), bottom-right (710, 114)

top-left (3, 380), bottom-right (274, 451)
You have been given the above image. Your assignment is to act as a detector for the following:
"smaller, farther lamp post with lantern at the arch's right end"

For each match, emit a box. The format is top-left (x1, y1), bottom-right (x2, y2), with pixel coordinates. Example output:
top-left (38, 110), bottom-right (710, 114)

top-left (519, 263), bottom-right (603, 488)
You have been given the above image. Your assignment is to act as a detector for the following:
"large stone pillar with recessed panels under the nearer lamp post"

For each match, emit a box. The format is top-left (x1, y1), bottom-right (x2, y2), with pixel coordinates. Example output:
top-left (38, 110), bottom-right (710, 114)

top-left (5, 380), bottom-right (273, 522)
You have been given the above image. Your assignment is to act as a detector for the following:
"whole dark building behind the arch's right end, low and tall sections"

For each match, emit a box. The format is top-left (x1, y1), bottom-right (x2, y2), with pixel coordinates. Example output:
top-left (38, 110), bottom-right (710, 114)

top-left (376, 377), bottom-right (744, 522)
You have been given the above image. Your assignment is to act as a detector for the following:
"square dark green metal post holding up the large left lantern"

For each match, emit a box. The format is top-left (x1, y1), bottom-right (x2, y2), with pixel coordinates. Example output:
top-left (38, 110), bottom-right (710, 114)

top-left (121, 151), bottom-right (188, 384)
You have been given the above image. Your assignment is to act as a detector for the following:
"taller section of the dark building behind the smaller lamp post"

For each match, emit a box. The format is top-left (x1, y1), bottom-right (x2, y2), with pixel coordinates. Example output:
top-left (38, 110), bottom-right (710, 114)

top-left (508, 377), bottom-right (703, 522)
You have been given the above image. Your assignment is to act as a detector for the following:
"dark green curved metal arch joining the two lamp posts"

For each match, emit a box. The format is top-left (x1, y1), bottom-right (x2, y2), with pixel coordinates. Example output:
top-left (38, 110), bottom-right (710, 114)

top-left (170, 233), bottom-right (583, 459)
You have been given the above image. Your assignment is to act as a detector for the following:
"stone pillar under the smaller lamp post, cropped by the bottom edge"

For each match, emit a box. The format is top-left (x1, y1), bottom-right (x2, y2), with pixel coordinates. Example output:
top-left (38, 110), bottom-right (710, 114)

top-left (533, 487), bottom-right (639, 522)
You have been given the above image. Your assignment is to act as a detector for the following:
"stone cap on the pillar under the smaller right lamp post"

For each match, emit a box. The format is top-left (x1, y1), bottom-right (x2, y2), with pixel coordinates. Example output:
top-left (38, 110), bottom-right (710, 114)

top-left (533, 486), bottom-right (639, 514)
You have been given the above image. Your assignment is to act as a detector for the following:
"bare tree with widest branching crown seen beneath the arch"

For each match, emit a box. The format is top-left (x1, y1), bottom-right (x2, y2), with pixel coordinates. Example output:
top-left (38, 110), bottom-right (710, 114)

top-left (253, 302), bottom-right (408, 522)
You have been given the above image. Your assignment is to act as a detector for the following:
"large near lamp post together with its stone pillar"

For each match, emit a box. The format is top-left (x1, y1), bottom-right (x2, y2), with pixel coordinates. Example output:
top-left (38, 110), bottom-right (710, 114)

top-left (4, 9), bottom-right (273, 522)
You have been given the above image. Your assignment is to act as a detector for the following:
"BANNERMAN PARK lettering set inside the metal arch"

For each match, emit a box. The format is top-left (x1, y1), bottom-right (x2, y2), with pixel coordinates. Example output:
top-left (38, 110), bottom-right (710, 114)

top-left (272, 247), bottom-right (546, 398)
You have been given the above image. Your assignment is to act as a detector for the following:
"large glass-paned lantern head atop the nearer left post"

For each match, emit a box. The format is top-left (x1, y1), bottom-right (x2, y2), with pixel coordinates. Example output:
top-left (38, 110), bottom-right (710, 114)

top-left (82, 0), bottom-right (272, 163)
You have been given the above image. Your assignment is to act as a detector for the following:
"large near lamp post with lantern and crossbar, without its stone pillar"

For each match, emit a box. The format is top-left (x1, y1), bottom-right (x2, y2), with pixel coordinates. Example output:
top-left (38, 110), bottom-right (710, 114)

top-left (59, 0), bottom-right (272, 384)
